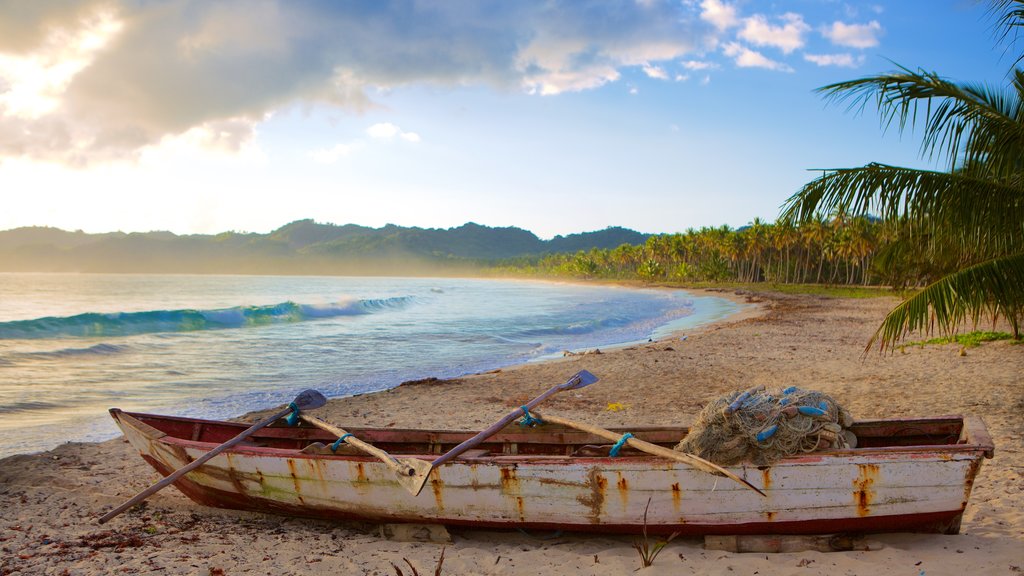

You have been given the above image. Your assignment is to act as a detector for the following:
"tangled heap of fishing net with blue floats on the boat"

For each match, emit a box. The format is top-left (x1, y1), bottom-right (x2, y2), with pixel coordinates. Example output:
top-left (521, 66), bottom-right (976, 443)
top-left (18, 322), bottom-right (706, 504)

top-left (675, 386), bottom-right (857, 465)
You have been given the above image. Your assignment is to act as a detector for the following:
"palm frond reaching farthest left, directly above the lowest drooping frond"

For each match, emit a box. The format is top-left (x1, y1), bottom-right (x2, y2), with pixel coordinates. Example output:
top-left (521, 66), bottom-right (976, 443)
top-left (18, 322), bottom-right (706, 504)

top-left (781, 163), bottom-right (1024, 252)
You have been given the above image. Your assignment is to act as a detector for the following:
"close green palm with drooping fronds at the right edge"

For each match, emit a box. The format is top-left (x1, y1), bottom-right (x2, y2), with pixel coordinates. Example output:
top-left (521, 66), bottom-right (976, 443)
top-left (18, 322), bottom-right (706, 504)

top-left (782, 0), bottom-right (1024, 351)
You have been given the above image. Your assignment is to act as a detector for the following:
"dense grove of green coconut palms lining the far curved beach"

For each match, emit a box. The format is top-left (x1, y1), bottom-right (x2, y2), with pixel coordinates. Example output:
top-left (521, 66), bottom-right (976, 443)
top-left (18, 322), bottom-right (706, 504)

top-left (498, 216), bottom-right (950, 288)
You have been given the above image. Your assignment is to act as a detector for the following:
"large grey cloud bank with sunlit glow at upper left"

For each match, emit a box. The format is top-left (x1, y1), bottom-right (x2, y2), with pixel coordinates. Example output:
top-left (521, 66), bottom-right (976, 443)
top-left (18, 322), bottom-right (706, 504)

top-left (0, 0), bottom-right (712, 164)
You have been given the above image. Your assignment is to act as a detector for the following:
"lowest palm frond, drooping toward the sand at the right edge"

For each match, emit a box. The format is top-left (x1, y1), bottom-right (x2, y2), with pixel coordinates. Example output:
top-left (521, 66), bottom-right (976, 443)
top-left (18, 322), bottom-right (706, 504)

top-left (865, 252), bottom-right (1024, 352)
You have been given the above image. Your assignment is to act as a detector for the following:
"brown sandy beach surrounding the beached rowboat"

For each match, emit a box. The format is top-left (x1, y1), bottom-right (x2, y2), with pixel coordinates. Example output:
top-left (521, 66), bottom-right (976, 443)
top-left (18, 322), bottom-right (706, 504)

top-left (0, 294), bottom-right (1024, 576)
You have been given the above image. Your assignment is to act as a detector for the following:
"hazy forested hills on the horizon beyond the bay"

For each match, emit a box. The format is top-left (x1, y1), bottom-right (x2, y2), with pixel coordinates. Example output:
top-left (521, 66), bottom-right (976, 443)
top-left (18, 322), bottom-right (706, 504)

top-left (0, 219), bottom-right (649, 275)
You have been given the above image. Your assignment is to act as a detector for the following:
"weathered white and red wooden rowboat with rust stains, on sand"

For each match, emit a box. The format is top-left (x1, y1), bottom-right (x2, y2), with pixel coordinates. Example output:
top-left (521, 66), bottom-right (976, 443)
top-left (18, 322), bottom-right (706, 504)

top-left (111, 408), bottom-right (993, 535)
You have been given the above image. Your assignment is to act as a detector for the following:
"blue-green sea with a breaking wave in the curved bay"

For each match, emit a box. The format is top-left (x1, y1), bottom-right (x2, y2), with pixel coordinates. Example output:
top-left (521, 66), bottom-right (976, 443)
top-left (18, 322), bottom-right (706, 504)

top-left (0, 274), bottom-right (737, 457)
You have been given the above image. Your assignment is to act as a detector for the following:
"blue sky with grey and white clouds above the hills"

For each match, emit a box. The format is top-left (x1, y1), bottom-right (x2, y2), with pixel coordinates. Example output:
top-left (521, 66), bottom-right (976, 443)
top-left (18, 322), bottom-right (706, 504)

top-left (0, 0), bottom-right (1014, 238)
